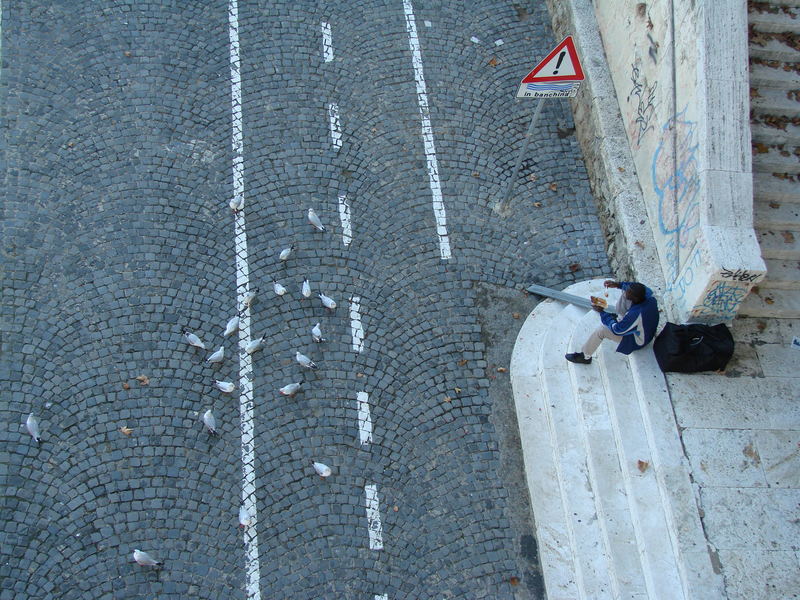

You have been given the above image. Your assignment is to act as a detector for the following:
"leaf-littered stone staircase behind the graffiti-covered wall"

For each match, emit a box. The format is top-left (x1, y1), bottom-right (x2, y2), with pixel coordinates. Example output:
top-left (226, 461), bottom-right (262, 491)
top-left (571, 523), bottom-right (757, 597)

top-left (739, 0), bottom-right (800, 318)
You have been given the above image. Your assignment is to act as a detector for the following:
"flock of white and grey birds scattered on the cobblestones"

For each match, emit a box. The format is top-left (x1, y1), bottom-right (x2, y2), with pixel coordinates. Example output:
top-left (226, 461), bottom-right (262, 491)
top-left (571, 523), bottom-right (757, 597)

top-left (25, 209), bottom-right (336, 568)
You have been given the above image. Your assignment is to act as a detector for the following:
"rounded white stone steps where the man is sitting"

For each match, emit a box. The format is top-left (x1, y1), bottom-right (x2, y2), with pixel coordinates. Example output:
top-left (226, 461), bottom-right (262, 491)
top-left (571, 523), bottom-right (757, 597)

top-left (511, 280), bottom-right (725, 600)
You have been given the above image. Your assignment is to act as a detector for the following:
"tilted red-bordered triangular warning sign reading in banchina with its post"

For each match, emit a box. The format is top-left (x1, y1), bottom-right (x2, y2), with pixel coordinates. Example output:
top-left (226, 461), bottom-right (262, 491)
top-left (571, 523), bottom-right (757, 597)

top-left (496, 35), bottom-right (584, 214)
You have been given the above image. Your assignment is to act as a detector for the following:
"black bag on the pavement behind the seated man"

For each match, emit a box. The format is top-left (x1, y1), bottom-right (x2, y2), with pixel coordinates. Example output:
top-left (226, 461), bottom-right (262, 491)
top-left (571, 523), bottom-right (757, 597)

top-left (653, 323), bottom-right (733, 373)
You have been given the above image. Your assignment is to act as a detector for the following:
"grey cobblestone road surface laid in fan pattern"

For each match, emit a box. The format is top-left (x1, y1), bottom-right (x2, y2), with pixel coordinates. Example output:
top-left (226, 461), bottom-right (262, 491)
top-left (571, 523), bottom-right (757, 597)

top-left (0, 0), bottom-right (607, 600)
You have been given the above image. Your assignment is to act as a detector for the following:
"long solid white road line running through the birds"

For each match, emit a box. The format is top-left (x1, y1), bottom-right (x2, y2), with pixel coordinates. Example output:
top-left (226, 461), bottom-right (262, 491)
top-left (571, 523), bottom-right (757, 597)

top-left (228, 0), bottom-right (261, 600)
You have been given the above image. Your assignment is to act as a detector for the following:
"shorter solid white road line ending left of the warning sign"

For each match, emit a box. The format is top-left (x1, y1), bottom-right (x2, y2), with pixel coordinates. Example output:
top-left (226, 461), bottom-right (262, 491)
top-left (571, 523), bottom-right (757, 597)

top-left (403, 0), bottom-right (451, 260)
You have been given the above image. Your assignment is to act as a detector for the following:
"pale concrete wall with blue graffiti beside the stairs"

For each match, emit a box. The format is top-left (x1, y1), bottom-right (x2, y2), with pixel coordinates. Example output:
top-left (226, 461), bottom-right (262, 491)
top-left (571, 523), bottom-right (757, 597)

top-left (549, 0), bottom-right (766, 322)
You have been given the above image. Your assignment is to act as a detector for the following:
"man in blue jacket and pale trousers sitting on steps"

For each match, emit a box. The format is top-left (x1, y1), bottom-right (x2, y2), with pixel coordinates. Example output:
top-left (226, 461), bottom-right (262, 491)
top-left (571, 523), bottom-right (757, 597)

top-left (564, 280), bottom-right (658, 365)
